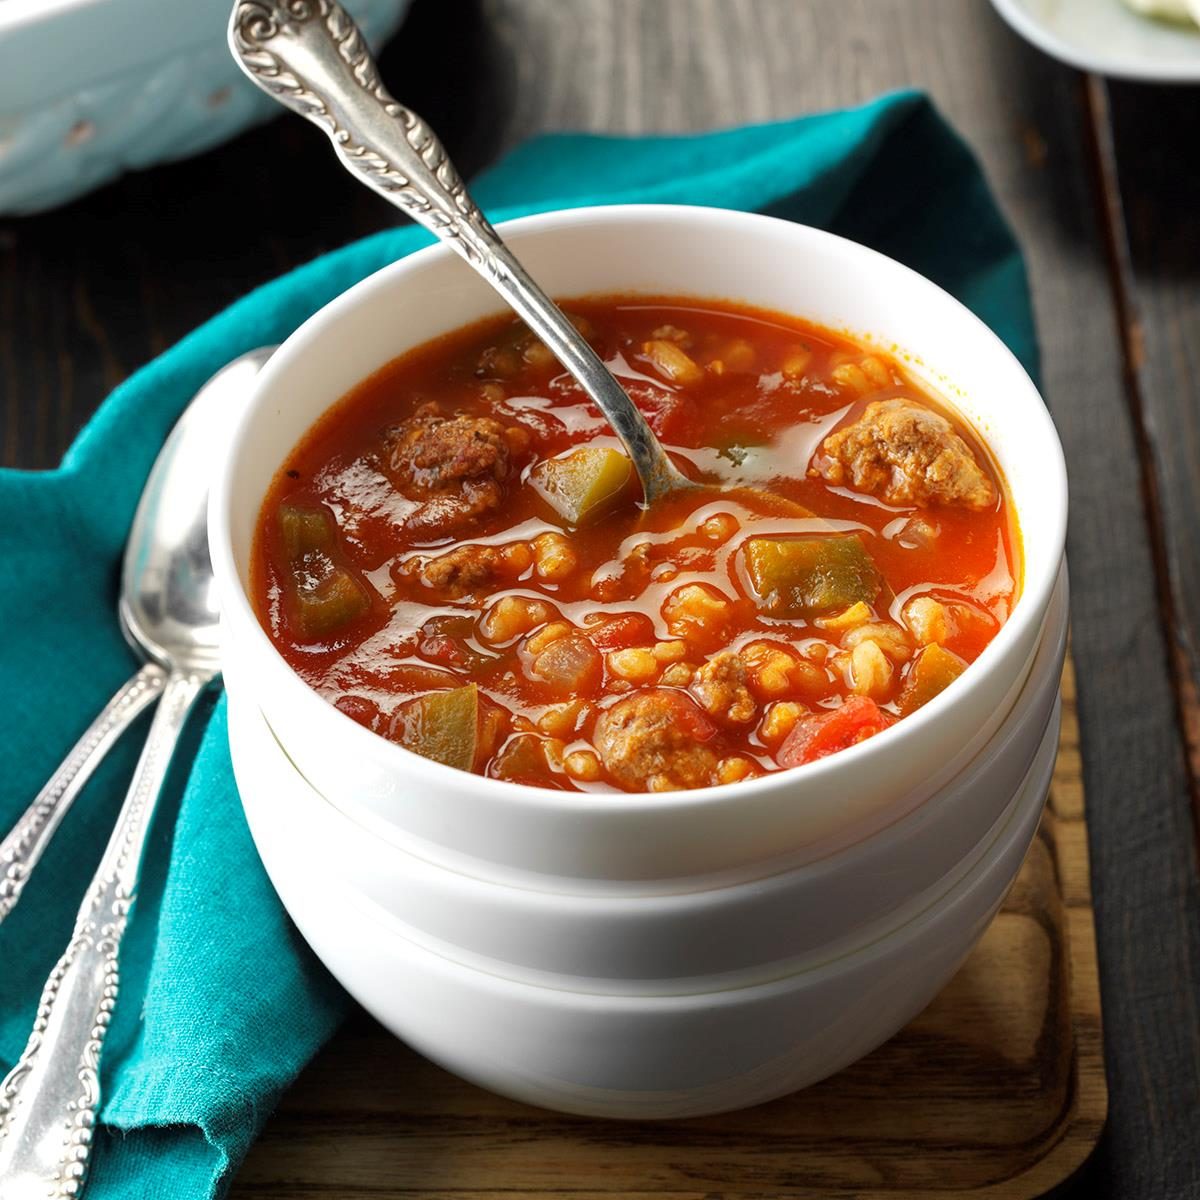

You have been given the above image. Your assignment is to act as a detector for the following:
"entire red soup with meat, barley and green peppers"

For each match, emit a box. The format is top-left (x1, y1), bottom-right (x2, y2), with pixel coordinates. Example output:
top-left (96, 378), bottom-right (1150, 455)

top-left (251, 296), bottom-right (1020, 792)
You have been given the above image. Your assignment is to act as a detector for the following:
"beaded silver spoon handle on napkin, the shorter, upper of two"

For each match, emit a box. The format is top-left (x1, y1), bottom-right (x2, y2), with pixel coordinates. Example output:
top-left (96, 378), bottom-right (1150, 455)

top-left (0, 662), bottom-right (167, 922)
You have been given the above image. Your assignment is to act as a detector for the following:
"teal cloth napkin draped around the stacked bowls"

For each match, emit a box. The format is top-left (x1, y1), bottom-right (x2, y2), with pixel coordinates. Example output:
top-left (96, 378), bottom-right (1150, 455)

top-left (0, 92), bottom-right (1037, 1200)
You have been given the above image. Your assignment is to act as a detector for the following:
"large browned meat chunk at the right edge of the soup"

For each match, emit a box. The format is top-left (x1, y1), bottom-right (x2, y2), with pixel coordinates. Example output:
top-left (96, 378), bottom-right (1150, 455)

top-left (812, 398), bottom-right (996, 511)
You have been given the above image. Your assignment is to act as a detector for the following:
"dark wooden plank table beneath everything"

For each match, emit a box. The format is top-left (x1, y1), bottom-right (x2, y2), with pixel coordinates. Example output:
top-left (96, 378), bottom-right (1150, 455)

top-left (0, 0), bottom-right (1200, 1200)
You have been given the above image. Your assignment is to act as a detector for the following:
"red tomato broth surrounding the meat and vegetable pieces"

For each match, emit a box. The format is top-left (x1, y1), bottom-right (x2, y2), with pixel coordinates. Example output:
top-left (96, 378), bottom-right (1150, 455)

top-left (251, 298), bottom-right (1020, 790)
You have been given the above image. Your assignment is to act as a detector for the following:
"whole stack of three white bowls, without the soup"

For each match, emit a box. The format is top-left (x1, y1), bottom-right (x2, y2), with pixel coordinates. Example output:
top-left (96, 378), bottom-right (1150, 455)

top-left (210, 205), bottom-right (1067, 1117)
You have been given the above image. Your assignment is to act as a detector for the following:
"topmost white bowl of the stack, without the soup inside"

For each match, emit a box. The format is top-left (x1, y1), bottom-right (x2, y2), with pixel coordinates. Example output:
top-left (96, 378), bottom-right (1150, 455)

top-left (209, 205), bottom-right (1067, 881)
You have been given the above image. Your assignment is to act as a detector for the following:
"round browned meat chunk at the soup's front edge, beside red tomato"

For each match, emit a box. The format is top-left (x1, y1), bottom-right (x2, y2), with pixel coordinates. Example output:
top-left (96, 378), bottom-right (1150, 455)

top-left (593, 688), bottom-right (718, 792)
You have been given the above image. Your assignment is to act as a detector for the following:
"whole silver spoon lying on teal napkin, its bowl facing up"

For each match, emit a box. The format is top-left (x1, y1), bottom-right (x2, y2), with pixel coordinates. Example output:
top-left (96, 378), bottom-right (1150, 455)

top-left (0, 349), bottom-right (270, 1200)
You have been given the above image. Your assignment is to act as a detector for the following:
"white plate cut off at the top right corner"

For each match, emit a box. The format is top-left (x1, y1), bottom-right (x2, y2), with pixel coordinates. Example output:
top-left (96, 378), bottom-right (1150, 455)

top-left (991, 0), bottom-right (1200, 83)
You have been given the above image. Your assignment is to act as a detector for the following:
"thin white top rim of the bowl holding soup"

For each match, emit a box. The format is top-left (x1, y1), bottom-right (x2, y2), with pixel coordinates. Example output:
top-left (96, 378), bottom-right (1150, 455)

top-left (209, 204), bottom-right (1068, 816)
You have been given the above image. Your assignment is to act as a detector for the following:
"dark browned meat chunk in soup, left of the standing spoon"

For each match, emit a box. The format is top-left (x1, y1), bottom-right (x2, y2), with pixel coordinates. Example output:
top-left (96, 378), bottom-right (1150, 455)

top-left (384, 404), bottom-right (528, 523)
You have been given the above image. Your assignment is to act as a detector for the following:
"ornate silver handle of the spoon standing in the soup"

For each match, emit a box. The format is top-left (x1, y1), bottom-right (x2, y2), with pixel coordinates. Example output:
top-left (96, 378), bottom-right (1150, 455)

top-left (229, 0), bottom-right (690, 503)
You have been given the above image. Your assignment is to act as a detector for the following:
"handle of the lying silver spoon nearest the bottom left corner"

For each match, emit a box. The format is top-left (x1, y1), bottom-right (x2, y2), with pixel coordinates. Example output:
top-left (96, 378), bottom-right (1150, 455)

top-left (0, 672), bottom-right (211, 1200)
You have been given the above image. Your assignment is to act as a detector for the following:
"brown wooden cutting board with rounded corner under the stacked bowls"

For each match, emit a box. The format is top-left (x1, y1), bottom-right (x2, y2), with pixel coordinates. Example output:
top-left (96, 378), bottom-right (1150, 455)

top-left (232, 661), bottom-right (1108, 1200)
